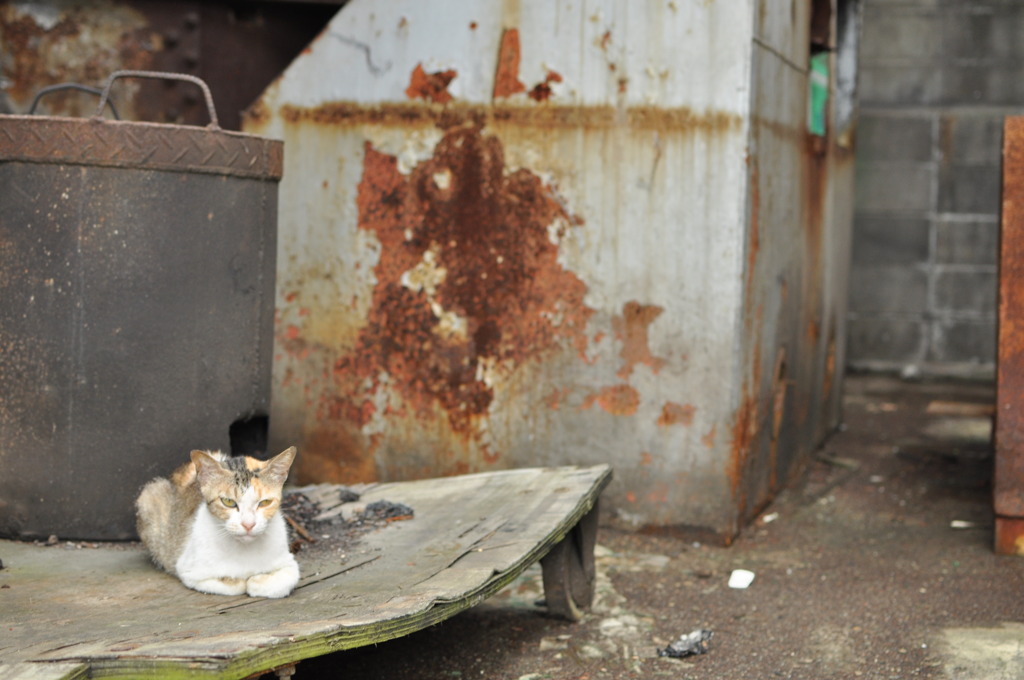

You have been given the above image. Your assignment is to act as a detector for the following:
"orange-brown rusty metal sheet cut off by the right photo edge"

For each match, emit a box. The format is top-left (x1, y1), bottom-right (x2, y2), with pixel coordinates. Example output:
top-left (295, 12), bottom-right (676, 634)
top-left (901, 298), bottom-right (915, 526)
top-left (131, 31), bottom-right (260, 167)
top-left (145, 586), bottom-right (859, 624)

top-left (993, 117), bottom-right (1024, 532)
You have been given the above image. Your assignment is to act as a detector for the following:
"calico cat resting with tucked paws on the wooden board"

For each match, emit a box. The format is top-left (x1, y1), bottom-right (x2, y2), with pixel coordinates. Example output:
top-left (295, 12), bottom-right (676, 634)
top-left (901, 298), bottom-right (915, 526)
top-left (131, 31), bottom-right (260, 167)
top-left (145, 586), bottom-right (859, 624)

top-left (135, 447), bottom-right (299, 597)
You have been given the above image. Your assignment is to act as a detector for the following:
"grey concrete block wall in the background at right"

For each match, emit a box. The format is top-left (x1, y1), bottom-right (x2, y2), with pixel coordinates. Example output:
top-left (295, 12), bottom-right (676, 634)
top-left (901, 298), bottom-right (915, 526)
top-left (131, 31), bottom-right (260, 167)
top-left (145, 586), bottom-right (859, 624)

top-left (848, 0), bottom-right (1024, 377)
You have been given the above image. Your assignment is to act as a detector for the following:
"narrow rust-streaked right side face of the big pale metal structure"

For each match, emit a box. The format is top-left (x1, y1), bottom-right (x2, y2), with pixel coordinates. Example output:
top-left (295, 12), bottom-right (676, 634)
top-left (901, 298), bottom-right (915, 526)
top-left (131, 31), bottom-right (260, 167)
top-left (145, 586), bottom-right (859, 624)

top-left (732, 0), bottom-right (859, 519)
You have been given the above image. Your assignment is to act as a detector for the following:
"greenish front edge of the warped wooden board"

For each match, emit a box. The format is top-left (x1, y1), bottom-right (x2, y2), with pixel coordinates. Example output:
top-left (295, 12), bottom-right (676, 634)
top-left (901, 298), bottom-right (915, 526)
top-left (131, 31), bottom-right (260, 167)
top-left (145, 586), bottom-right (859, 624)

top-left (44, 465), bottom-right (611, 680)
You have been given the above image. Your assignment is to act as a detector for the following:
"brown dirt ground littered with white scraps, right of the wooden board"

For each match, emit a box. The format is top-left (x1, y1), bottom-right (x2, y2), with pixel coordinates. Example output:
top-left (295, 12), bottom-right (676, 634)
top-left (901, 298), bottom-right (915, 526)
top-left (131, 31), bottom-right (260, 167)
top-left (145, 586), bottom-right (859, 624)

top-left (295, 376), bottom-right (1024, 680)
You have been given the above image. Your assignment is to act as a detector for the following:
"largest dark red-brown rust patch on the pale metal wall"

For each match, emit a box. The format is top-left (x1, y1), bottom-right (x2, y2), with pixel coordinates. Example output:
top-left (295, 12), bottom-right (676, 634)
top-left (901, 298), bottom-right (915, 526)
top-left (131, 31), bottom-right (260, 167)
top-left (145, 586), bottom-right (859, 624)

top-left (328, 124), bottom-right (592, 460)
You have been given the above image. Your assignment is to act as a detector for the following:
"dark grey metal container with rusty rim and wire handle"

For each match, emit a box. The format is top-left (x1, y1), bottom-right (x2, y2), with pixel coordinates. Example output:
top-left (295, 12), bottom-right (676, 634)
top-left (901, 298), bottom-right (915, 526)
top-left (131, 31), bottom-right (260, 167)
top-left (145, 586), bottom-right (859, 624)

top-left (0, 72), bottom-right (283, 539)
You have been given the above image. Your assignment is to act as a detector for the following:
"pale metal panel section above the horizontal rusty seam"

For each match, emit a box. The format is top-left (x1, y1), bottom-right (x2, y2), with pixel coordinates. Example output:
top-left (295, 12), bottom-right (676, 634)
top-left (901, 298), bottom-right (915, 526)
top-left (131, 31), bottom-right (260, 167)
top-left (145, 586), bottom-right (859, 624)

top-left (258, 0), bottom-right (753, 110)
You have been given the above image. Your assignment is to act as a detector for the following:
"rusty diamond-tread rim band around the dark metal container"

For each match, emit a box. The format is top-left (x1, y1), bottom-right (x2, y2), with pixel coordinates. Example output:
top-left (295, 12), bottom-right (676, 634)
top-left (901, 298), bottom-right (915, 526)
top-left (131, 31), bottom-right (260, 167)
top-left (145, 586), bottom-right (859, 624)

top-left (0, 115), bottom-right (284, 181)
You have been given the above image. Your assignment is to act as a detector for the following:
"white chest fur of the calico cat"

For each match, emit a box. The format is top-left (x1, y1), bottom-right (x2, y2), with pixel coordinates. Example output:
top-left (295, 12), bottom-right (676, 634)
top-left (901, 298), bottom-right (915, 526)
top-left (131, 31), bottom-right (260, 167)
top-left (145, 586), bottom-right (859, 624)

top-left (175, 505), bottom-right (295, 580)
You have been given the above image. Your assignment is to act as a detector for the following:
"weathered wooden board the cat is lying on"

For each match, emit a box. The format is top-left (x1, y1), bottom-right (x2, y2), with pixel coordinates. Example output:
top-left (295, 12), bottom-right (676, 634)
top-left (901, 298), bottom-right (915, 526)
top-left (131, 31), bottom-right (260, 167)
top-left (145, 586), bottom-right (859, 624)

top-left (0, 466), bottom-right (611, 678)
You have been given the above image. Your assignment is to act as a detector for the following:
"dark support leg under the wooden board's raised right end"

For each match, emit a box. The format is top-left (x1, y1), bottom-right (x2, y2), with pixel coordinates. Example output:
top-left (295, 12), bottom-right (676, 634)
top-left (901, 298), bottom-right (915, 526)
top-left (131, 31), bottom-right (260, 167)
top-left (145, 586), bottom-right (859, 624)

top-left (541, 503), bottom-right (598, 621)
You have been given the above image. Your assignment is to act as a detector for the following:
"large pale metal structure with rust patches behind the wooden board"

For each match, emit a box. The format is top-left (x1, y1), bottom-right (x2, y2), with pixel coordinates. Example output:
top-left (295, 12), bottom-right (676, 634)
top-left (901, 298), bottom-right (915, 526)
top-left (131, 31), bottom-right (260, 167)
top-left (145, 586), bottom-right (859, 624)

top-left (245, 0), bottom-right (850, 540)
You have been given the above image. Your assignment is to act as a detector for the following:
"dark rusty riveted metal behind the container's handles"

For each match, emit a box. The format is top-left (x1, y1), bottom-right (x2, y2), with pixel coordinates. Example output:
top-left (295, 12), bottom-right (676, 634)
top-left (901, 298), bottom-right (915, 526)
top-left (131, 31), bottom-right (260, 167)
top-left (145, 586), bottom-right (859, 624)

top-left (0, 0), bottom-right (333, 130)
